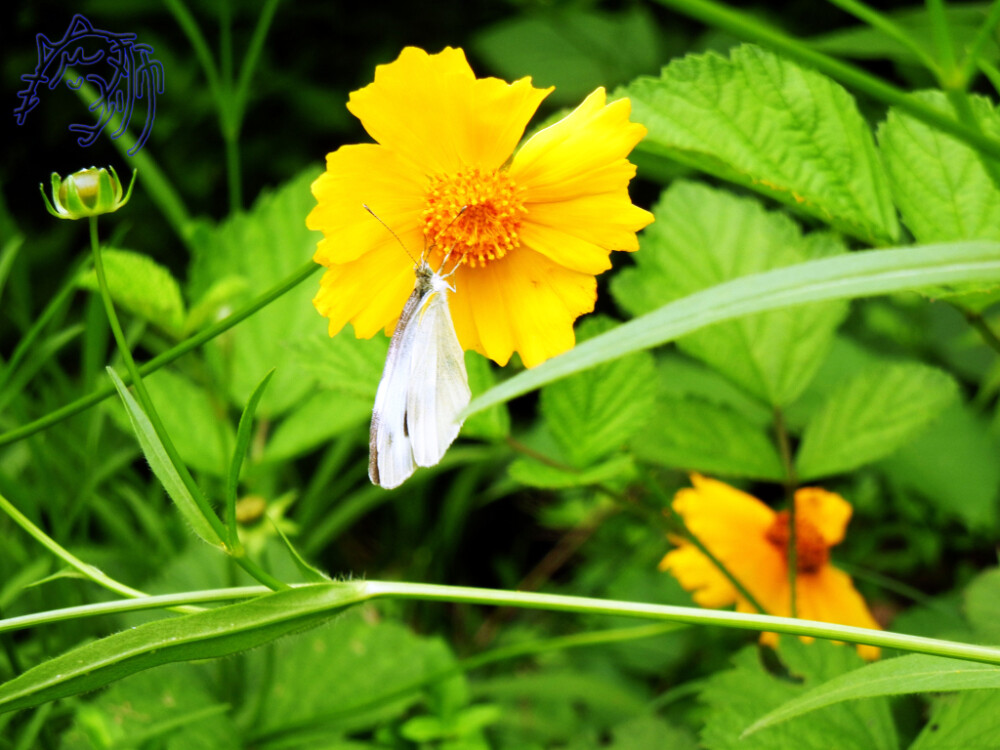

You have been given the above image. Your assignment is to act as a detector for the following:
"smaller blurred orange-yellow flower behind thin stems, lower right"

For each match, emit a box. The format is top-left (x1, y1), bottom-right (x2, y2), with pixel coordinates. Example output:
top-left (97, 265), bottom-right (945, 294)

top-left (660, 474), bottom-right (879, 659)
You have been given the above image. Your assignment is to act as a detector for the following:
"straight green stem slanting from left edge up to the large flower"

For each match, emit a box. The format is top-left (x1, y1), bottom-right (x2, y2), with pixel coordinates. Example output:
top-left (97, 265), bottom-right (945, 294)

top-left (0, 260), bottom-right (320, 447)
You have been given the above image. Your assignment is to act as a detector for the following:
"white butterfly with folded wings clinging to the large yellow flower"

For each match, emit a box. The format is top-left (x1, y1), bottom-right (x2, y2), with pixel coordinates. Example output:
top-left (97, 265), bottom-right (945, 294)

top-left (368, 254), bottom-right (471, 489)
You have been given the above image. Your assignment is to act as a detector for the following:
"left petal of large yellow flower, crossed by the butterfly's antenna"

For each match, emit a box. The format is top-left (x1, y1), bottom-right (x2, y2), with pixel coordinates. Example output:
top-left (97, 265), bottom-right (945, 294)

top-left (306, 144), bottom-right (427, 266)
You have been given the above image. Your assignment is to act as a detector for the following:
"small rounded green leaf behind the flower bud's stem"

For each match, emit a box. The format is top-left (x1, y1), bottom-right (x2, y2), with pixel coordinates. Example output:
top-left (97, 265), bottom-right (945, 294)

top-left (78, 248), bottom-right (187, 338)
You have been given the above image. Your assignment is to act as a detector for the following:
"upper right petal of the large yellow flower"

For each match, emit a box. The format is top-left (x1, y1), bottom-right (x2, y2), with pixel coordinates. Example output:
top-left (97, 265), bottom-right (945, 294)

top-left (510, 89), bottom-right (652, 203)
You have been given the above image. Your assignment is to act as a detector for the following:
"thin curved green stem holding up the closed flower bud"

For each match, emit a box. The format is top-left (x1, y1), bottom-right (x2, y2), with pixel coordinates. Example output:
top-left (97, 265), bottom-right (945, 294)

top-left (90, 216), bottom-right (288, 591)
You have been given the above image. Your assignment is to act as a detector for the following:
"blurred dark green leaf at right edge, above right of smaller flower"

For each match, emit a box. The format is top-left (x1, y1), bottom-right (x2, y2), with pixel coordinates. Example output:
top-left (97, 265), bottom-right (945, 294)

top-left (880, 401), bottom-right (1000, 531)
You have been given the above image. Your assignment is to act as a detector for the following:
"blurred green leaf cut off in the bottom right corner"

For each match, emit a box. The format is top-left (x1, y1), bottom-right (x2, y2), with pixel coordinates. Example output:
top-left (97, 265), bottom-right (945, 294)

top-left (909, 690), bottom-right (1000, 750)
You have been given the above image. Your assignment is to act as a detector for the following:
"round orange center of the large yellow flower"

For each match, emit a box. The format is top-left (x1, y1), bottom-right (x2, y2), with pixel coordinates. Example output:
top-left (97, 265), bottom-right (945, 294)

top-left (424, 167), bottom-right (525, 266)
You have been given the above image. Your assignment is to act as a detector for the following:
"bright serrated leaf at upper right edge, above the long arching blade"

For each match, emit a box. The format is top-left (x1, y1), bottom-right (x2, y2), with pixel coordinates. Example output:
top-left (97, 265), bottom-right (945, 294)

top-left (878, 91), bottom-right (1000, 310)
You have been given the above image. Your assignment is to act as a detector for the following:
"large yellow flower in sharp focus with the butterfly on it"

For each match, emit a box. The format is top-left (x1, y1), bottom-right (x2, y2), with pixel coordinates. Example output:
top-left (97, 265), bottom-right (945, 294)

top-left (306, 47), bottom-right (653, 367)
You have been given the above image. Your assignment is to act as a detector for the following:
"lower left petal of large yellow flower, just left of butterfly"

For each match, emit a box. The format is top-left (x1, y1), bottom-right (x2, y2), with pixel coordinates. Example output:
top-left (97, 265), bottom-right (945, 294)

top-left (313, 240), bottom-right (414, 339)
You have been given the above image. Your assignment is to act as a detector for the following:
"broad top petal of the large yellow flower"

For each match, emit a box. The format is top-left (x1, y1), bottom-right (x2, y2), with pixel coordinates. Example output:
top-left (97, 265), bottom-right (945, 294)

top-left (347, 47), bottom-right (551, 175)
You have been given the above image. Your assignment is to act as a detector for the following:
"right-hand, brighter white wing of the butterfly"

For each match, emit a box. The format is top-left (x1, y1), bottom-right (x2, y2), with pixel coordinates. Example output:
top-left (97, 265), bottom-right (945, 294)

top-left (406, 274), bottom-right (471, 466)
